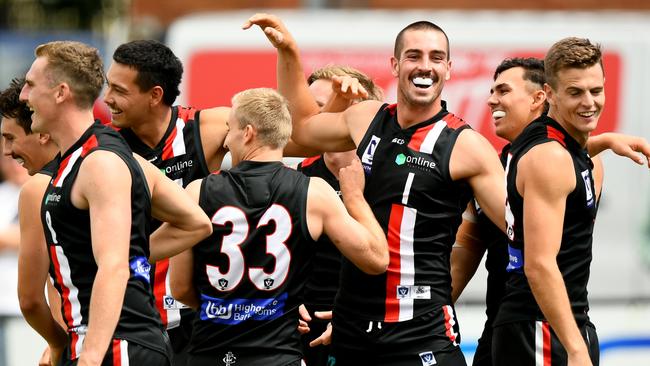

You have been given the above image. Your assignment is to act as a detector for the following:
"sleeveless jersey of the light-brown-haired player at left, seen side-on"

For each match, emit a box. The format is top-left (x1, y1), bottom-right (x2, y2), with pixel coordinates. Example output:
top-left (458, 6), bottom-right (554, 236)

top-left (41, 122), bottom-right (166, 359)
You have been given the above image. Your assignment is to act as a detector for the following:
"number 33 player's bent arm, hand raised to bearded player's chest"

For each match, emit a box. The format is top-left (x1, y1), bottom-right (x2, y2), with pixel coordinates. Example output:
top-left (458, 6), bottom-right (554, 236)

top-left (307, 160), bottom-right (388, 274)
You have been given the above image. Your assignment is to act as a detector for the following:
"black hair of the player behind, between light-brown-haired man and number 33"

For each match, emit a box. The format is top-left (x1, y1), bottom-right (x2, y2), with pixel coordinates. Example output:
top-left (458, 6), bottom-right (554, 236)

top-left (113, 40), bottom-right (183, 106)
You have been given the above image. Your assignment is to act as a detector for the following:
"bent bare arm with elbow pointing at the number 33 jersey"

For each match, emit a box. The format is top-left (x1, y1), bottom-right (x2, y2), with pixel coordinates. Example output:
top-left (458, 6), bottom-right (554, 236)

top-left (134, 154), bottom-right (212, 261)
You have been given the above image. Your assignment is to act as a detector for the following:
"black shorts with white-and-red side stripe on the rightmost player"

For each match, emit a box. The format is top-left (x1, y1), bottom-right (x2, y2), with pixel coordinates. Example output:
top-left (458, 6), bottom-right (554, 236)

top-left (492, 321), bottom-right (600, 366)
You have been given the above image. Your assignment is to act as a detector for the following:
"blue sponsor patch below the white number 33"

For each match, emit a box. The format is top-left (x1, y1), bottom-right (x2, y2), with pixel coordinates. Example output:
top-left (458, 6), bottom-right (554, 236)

top-left (199, 292), bottom-right (287, 325)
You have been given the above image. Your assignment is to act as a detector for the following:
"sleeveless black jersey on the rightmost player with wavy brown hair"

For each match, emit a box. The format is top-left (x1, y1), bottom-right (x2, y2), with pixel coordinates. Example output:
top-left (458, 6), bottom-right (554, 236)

top-left (495, 116), bottom-right (598, 324)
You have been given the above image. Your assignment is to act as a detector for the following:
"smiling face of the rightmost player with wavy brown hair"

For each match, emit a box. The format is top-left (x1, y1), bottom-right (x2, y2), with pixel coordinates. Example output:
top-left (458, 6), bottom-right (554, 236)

top-left (545, 64), bottom-right (605, 143)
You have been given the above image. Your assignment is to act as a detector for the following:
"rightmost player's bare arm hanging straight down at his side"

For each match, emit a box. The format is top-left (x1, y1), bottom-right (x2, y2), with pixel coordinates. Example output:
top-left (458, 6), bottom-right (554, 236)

top-left (516, 142), bottom-right (590, 364)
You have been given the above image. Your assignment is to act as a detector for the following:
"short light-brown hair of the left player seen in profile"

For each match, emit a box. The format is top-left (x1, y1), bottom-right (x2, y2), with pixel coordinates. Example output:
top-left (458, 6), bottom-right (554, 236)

top-left (34, 41), bottom-right (105, 108)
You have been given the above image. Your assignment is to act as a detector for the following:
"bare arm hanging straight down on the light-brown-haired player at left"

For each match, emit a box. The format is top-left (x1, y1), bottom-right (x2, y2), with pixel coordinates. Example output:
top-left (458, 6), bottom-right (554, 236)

top-left (71, 150), bottom-right (132, 365)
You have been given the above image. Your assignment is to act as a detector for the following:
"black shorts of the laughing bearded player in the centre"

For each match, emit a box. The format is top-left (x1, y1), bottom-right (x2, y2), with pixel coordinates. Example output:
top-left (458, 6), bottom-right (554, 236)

top-left (329, 307), bottom-right (467, 366)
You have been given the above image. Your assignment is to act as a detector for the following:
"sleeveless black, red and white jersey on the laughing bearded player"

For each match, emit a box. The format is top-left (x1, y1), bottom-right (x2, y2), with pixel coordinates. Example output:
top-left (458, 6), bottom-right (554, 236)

top-left (335, 104), bottom-right (472, 322)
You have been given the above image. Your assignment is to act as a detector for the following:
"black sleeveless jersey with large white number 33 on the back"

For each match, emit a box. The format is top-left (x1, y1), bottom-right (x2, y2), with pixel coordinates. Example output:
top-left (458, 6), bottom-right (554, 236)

top-left (189, 161), bottom-right (315, 365)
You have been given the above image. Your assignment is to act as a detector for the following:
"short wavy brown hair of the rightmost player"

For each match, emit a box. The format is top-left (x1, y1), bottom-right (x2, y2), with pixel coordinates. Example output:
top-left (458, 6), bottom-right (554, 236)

top-left (544, 37), bottom-right (603, 89)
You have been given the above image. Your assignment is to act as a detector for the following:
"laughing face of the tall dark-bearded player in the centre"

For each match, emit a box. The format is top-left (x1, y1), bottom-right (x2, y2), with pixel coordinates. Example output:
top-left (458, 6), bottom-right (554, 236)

top-left (391, 30), bottom-right (451, 107)
